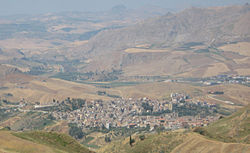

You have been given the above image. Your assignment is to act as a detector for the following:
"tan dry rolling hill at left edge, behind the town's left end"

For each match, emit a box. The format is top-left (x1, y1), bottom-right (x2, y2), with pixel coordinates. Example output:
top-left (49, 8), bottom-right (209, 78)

top-left (0, 75), bottom-right (110, 103)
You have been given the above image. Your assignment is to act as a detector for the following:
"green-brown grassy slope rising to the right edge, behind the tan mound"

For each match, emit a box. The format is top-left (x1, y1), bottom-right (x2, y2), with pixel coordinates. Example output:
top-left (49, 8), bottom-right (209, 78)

top-left (195, 105), bottom-right (250, 144)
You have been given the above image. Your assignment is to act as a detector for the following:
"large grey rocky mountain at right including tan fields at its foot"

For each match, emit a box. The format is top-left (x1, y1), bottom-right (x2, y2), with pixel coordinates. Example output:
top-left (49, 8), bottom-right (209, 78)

top-left (78, 5), bottom-right (250, 77)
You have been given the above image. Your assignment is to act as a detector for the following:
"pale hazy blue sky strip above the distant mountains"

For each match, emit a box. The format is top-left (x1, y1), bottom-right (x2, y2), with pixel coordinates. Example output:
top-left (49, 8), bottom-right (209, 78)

top-left (0, 0), bottom-right (250, 16)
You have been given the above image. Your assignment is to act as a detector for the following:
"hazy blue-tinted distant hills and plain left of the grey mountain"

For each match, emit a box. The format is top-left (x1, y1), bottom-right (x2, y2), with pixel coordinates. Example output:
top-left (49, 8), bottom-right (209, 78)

top-left (0, 6), bottom-right (170, 80)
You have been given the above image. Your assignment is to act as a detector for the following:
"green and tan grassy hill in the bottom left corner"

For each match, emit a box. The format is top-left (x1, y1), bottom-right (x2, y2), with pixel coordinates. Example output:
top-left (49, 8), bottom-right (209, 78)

top-left (0, 131), bottom-right (91, 153)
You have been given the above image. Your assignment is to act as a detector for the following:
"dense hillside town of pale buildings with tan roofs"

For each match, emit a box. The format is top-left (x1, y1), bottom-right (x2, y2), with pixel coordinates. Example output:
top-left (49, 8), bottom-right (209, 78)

top-left (46, 93), bottom-right (218, 130)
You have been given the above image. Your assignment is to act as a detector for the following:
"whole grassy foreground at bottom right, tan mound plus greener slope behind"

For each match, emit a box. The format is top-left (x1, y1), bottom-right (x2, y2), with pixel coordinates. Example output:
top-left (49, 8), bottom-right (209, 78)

top-left (98, 105), bottom-right (250, 153)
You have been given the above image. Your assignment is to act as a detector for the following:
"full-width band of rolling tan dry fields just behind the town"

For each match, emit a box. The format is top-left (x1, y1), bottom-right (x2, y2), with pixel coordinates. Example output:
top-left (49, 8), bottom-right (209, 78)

top-left (0, 74), bottom-right (250, 105)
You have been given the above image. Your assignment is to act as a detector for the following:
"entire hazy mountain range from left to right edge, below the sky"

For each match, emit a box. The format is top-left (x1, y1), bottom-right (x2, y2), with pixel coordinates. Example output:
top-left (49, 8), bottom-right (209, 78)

top-left (0, 5), bottom-right (250, 80)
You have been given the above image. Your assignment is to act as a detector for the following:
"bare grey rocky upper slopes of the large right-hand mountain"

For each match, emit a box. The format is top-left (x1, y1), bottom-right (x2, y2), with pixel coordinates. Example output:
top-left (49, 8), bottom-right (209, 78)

top-left (85, 5), bottom-right (250, 49)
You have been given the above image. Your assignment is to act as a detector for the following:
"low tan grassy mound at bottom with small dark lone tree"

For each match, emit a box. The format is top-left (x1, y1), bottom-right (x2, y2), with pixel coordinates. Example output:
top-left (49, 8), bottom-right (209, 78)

top-left (98, 132), bottom-right (250, 153)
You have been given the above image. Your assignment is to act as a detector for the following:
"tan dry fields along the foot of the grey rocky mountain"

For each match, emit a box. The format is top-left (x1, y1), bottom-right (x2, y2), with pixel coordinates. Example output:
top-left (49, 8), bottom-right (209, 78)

top-left (123, 43), bottom-right (250, 78)
